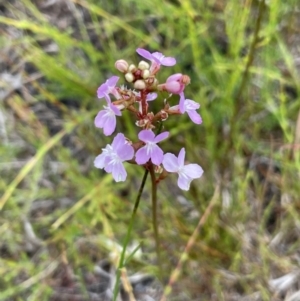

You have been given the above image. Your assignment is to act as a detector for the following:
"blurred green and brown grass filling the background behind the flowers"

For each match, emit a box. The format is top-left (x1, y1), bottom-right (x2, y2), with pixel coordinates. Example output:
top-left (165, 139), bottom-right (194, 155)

top-left (0, 0), bottom-right (300, 301)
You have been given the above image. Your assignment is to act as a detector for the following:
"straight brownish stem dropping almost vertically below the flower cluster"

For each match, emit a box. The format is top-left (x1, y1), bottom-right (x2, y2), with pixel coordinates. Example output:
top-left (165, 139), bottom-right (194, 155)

top-left (149, 163), bottom-right (160, 267)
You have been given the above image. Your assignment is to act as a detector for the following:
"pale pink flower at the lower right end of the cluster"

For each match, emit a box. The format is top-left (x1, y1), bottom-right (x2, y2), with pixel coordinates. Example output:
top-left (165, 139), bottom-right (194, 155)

top-left (162, 148), bottom-right (203, 190)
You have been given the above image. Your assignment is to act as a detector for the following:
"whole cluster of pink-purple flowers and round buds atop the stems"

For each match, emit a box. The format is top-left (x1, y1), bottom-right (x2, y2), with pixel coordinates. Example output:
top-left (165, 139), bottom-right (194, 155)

top-left (94, 48), bottom-right (203, 190)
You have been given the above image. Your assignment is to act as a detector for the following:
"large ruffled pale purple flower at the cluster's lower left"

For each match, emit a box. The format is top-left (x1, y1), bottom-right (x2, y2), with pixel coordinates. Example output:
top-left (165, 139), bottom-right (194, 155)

top-left (94, 133), bottom-right (134, 182)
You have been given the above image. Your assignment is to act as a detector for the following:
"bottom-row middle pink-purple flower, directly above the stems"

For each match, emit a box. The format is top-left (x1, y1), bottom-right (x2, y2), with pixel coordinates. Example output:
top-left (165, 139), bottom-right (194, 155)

top-left (135, 130), bottom-right (169, 165)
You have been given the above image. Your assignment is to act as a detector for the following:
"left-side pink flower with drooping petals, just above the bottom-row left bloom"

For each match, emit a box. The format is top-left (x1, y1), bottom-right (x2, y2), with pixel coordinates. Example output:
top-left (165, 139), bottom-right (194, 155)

top-left (94, 97), bottom-right (122, 136)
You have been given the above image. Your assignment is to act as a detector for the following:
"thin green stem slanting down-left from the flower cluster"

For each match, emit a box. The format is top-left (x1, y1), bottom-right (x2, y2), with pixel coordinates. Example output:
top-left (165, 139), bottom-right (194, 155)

top-left (113, 170), bottom-right (149, 301)
